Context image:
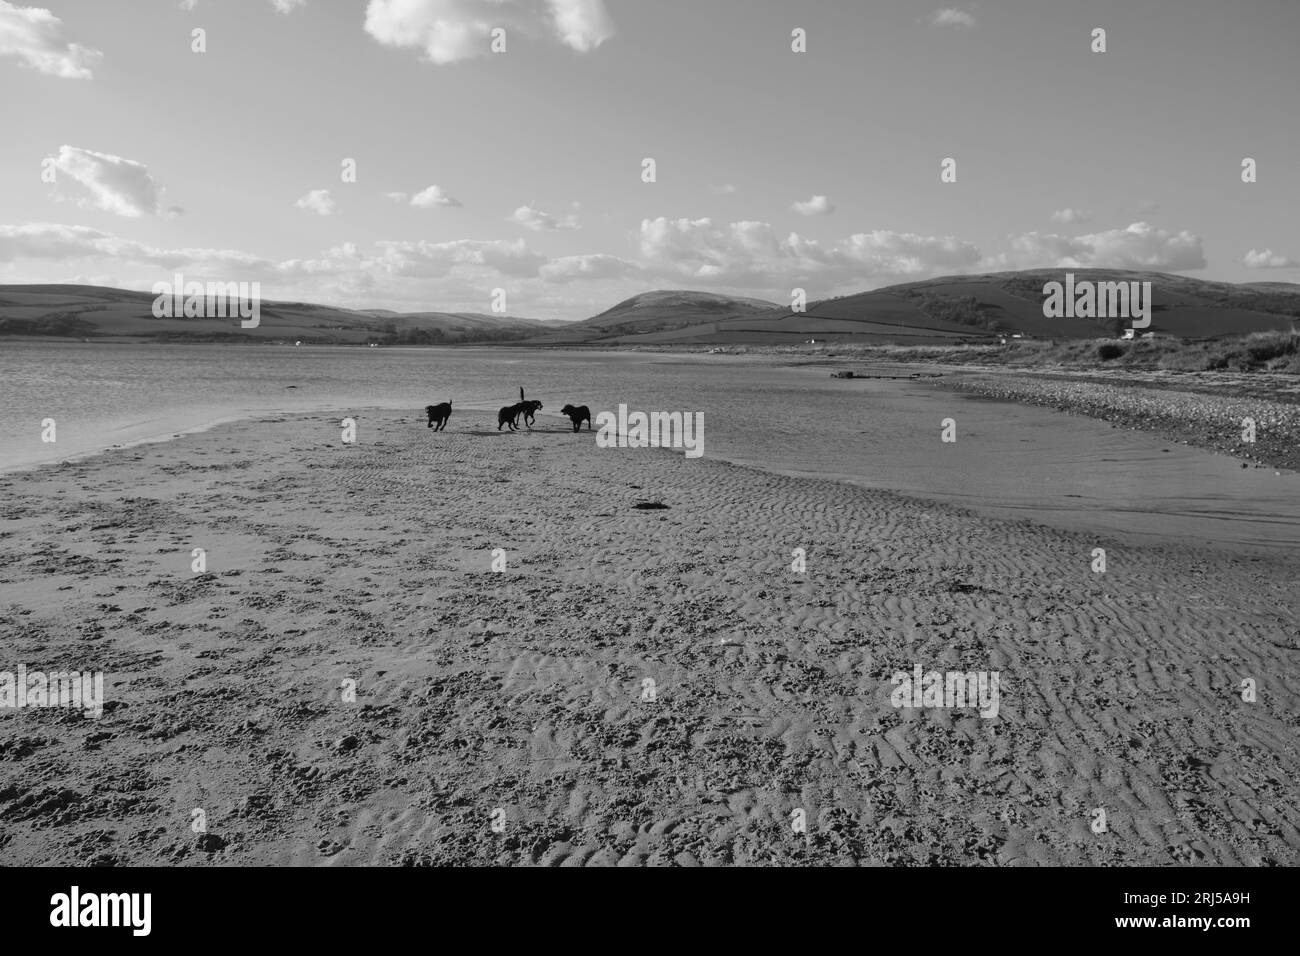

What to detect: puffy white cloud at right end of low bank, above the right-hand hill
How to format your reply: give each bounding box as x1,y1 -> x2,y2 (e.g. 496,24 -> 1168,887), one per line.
1000,222 -> 1205,272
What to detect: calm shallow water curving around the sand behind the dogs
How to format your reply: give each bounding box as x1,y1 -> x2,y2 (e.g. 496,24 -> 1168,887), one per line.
0,343 -> 1300,554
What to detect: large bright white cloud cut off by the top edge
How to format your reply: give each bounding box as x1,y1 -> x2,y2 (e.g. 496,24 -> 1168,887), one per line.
365,0 -> 614,64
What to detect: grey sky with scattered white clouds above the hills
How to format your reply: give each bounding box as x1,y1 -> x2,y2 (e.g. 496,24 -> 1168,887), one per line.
0,0 -> 1300,319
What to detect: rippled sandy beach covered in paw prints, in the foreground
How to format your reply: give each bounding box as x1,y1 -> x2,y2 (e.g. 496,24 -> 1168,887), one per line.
0,411 -> 1300,866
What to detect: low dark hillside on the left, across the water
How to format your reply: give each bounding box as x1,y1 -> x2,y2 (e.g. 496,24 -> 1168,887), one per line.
0,285 -> 559,345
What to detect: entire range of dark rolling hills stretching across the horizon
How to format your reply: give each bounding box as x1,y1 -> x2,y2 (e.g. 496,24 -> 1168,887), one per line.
0,269 -> 1300,346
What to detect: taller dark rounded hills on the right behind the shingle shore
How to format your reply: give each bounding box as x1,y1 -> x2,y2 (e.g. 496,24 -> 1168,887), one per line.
517,269 -> 1300,345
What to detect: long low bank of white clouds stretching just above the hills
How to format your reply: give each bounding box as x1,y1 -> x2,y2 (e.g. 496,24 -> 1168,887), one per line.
0,215 -> 1216,317
